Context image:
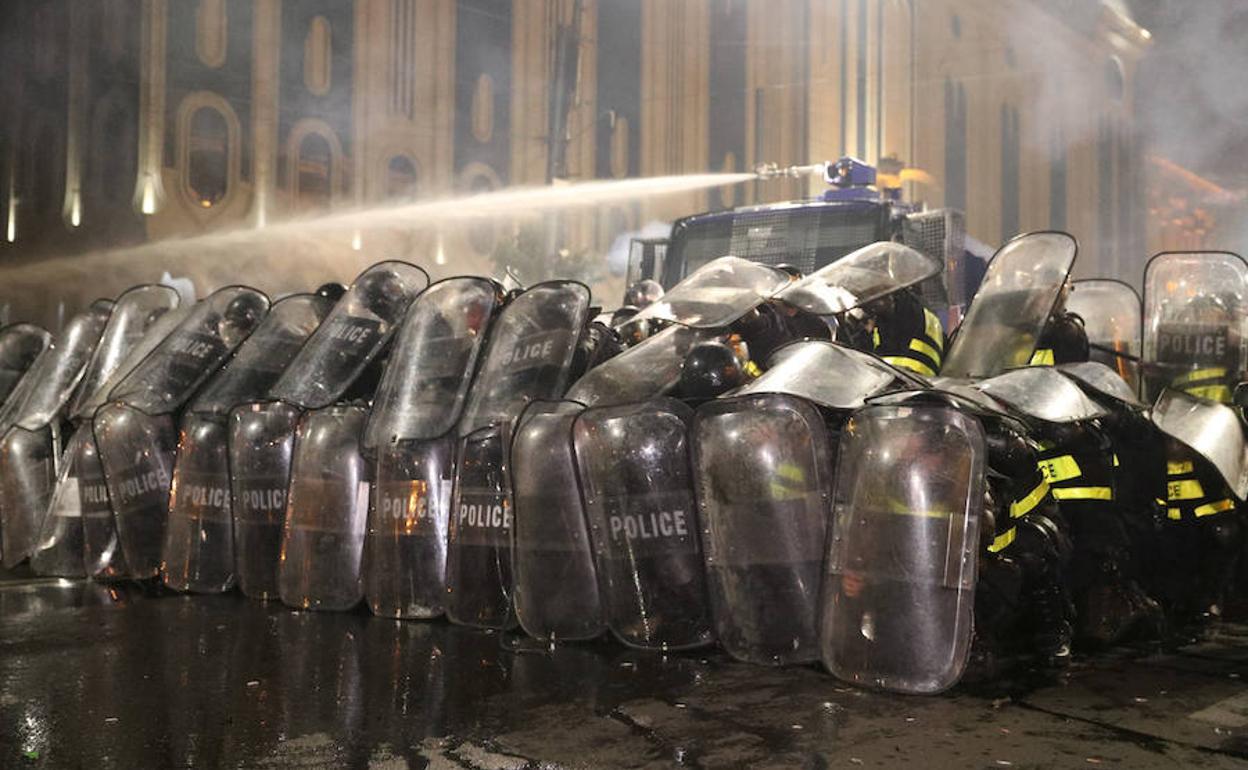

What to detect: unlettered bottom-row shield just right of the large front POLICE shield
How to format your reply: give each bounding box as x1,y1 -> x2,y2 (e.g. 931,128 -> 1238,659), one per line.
693,396 -> 832,665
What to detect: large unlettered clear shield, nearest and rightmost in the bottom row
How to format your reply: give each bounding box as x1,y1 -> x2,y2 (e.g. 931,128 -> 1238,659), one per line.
820,406 -> 987,693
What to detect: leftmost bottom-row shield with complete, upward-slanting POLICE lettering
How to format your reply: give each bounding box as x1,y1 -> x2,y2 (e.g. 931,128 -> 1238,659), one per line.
92,403 -> 177,578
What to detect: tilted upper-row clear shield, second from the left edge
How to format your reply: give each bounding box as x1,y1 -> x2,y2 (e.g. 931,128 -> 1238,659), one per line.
0,303 -> 111,431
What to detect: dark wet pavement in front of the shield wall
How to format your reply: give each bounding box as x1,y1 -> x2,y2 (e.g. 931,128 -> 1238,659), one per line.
0,579 -> 1248,770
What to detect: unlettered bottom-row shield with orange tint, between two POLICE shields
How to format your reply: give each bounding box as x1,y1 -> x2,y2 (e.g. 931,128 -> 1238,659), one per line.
277,406 -> 369,610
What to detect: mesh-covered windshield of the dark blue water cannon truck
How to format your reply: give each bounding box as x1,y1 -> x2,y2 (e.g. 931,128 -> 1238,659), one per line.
663,202 -> 887,287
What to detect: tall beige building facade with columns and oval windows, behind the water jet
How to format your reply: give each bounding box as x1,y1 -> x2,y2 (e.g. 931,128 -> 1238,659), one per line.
0,0 -> 1148,324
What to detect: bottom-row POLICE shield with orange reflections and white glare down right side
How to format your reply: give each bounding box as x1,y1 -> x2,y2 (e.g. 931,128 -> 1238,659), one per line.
364,436 -> 454,618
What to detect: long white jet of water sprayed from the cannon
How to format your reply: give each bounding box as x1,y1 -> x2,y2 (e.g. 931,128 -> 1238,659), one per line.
0,173 -> 756,326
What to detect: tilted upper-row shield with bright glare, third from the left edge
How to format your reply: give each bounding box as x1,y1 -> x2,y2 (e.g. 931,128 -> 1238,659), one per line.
69,283 -> 180,421
